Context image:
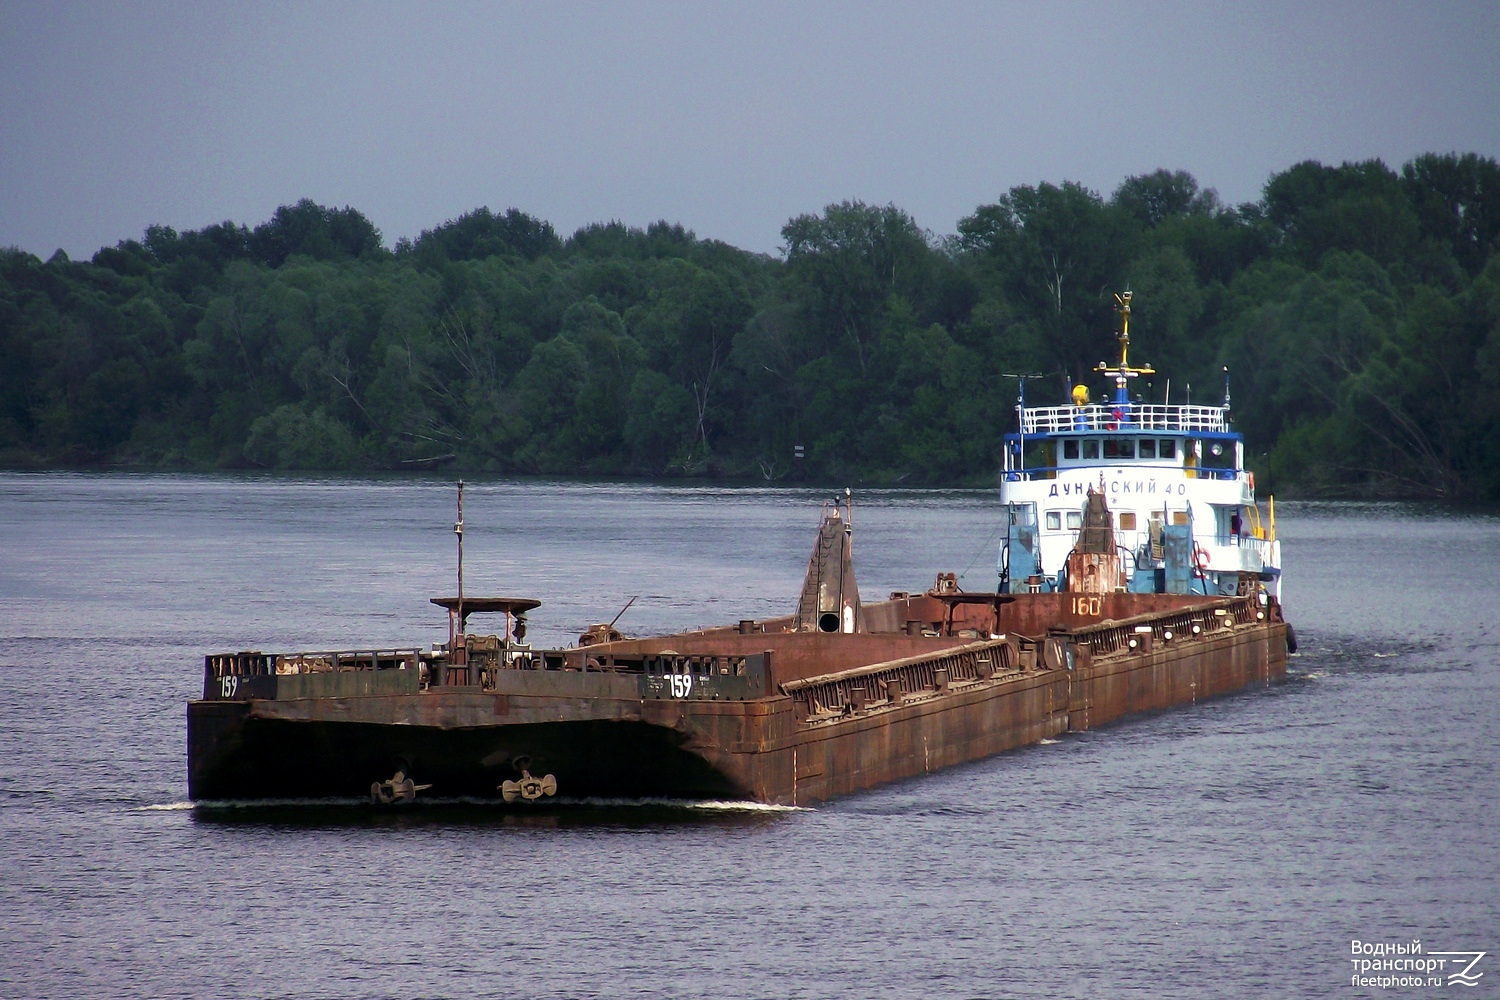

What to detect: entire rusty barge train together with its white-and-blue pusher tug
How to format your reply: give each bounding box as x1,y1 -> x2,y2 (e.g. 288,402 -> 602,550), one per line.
188,294 -> 1295,805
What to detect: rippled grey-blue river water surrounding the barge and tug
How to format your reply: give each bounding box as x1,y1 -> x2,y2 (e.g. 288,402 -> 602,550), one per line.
0,474 -> 1500,997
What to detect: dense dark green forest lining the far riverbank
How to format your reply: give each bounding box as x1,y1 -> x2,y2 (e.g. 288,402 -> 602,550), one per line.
0,154 -> 1500,501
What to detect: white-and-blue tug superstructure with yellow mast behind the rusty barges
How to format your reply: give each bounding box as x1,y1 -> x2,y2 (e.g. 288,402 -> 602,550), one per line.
999,292 -> 1281,598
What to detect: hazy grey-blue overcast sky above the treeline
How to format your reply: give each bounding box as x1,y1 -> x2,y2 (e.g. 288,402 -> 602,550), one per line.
0,0 -> 1500,259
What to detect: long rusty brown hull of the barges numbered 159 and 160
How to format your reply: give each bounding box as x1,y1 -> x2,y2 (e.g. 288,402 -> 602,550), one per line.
188,594 -> 1287,805
